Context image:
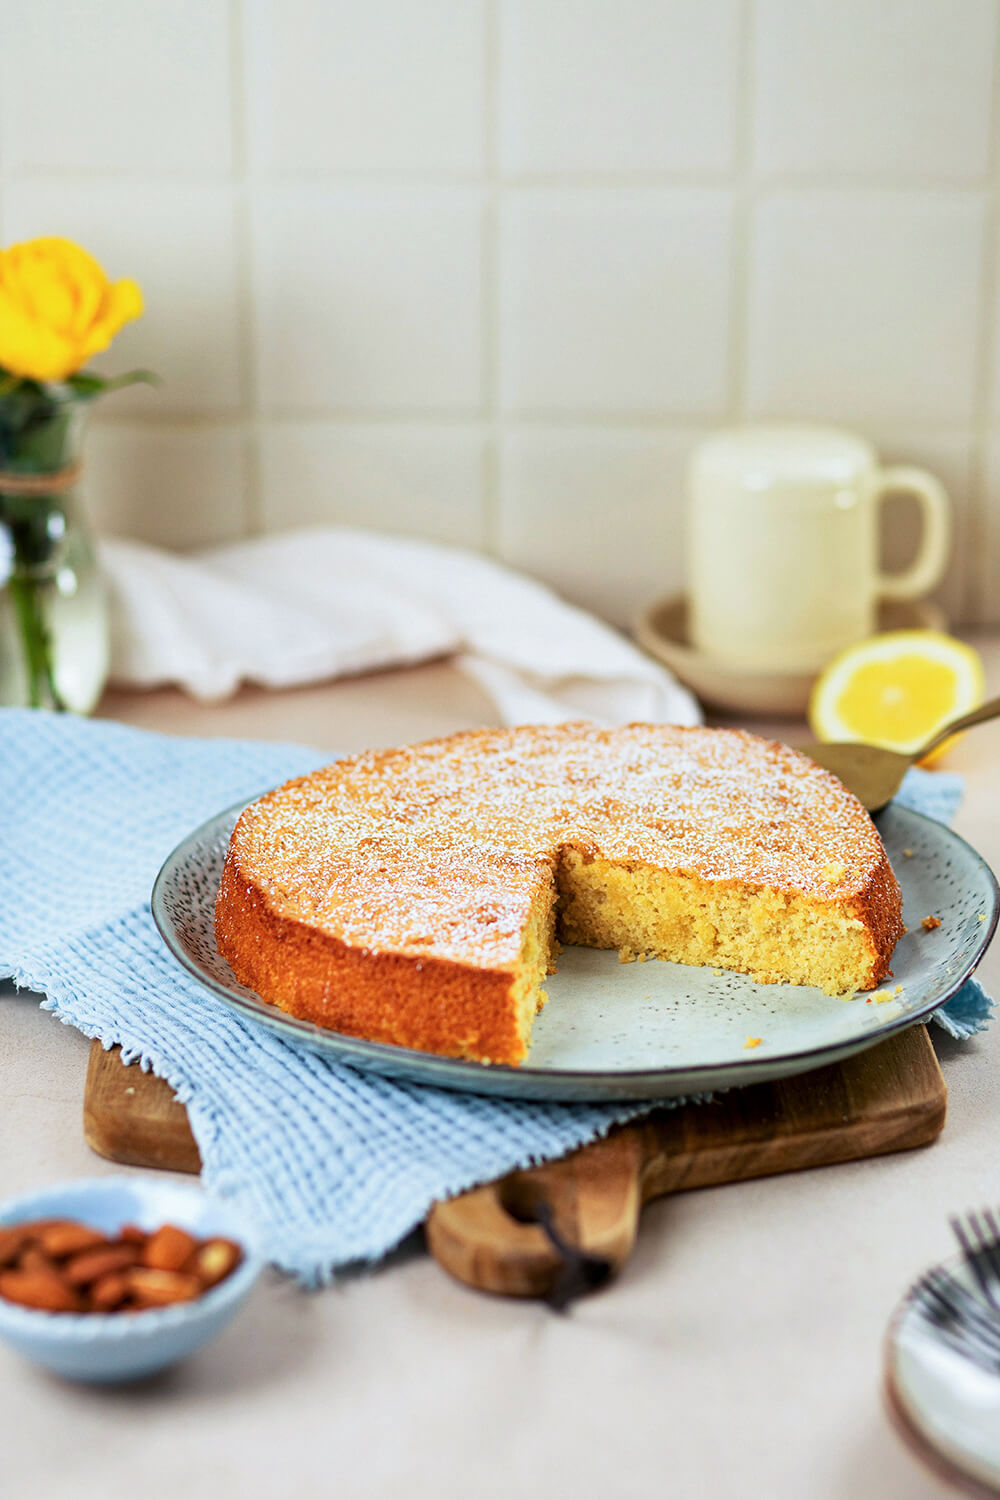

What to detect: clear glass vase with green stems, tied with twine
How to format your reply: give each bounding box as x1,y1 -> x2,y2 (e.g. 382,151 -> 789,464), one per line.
0,399 -> 108,714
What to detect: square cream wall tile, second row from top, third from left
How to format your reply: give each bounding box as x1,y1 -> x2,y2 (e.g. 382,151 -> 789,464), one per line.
499,188 -> 732,416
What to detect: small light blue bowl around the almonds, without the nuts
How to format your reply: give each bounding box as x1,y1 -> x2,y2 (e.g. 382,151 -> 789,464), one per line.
0,1176 -> 261,1382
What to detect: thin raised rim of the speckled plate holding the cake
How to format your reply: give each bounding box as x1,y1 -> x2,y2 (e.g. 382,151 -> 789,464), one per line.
150,792 -> 1000,1101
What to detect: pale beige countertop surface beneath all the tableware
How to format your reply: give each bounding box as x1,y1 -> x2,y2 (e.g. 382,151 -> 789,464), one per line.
0,641 -> 1000,1500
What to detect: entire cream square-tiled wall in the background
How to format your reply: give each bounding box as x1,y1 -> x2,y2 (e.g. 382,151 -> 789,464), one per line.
0,0 -> 1000,623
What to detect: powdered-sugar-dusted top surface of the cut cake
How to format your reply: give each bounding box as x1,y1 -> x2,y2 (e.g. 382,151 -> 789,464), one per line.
232,725 -> 885,968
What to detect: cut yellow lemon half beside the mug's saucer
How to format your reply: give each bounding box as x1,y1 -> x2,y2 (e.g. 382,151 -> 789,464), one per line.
810,630 -> 987,759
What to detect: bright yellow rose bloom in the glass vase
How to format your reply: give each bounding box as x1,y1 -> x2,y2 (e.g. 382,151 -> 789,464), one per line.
0,239 -> 142,381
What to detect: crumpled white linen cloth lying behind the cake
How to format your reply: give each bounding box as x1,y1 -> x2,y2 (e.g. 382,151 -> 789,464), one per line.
100,527 -> 702,725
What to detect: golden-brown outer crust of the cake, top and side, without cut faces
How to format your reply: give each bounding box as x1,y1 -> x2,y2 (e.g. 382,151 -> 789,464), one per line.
216,725 -> 903,1062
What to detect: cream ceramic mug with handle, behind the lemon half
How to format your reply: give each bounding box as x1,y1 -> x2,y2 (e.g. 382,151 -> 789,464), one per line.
688,425 -> 951,672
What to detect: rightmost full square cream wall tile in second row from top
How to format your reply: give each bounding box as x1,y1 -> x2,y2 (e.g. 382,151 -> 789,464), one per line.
748,189 -> 987,425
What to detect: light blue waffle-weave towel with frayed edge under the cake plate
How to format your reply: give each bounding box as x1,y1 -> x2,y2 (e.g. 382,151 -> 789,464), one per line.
0,710 -> 991,1283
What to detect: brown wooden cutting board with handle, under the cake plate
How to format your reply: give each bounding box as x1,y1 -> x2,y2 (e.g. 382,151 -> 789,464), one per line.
84,1026 -> 948,1307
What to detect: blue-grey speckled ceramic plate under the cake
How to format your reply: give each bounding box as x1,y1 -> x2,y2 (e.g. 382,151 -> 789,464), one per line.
153,807 -> 1000,1100
